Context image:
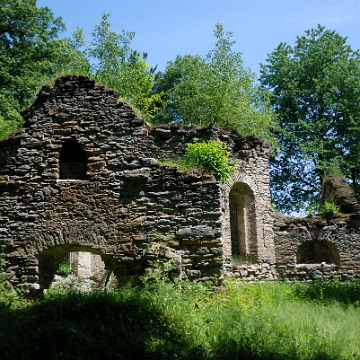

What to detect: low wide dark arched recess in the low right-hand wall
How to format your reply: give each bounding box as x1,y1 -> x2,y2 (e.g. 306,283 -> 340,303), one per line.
296,240 -> 340,266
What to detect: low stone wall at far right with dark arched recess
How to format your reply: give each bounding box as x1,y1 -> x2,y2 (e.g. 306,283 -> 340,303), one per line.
274,213 -> 360,280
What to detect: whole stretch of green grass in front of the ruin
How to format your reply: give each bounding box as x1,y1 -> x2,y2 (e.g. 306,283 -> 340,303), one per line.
0,281 -> 360,360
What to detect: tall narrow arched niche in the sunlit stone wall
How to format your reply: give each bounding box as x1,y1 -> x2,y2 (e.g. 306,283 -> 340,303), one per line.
229,182 -> 258,260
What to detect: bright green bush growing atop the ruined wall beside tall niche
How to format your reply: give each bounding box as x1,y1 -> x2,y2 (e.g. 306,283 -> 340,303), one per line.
186,140 -> 235,182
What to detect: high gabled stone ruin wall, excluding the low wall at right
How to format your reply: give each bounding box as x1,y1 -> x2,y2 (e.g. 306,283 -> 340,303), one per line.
0,77 -> 274,292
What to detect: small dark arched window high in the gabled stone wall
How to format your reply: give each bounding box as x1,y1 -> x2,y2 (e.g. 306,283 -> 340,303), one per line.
60,140 -> 86,180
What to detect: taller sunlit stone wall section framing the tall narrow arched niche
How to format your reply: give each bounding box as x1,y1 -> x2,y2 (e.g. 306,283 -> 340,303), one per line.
154,126 -> 275,264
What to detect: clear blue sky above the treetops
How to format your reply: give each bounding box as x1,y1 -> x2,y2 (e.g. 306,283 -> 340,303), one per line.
37,0 -> 360,73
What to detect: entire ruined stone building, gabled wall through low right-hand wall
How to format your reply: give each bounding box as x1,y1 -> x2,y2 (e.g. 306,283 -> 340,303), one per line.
0,76 -> 360,294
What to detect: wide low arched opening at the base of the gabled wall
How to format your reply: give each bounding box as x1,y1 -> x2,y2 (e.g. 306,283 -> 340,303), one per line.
37,245 -> 116,292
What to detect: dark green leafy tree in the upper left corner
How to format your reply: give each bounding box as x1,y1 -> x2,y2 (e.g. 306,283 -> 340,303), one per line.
0,0 -> 64,138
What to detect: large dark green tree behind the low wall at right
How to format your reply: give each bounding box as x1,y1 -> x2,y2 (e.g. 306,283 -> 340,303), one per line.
260,25 -> 360,212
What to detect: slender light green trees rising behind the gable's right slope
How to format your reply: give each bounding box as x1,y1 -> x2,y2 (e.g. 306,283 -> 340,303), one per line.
67,13 -> 159,118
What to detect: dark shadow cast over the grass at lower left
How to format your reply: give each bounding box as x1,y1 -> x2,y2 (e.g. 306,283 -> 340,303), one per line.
0,283 -> 348,360
